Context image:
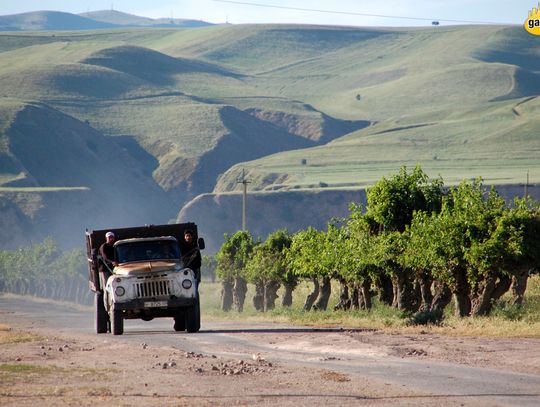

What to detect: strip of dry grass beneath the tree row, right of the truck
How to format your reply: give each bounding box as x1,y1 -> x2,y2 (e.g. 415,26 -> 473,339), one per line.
200,275 -> 540,338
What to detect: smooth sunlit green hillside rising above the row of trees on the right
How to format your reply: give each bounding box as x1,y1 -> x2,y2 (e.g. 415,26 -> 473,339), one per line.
210,27 -> 540,192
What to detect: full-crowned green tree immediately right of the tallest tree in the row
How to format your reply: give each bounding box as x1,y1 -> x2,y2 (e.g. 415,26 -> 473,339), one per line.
405,180 -> 522,316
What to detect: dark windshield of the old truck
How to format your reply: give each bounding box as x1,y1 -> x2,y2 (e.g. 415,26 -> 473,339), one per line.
116,240 -> 180,263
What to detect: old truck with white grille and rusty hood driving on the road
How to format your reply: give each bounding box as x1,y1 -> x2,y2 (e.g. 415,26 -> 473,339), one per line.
86,222 -> 204,335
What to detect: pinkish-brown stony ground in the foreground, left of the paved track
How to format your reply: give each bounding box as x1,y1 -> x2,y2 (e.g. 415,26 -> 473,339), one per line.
0,325 -> 418,406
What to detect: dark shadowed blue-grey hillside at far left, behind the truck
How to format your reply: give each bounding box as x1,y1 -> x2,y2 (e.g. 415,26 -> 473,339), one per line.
0,104 -> 175,247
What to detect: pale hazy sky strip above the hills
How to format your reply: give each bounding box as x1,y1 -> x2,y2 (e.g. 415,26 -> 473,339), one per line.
0,0 -> 538,26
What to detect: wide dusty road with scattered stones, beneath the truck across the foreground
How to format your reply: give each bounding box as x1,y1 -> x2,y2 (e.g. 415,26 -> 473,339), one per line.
0,296 -> 540,406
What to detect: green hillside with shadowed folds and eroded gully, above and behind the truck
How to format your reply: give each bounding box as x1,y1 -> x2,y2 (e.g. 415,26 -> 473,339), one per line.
0,31 -> 367,206
